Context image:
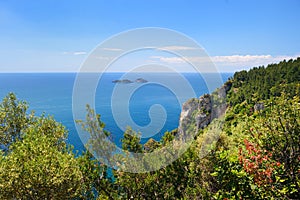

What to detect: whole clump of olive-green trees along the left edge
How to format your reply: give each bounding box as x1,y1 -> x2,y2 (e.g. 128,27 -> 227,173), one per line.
0,93 -> 103,199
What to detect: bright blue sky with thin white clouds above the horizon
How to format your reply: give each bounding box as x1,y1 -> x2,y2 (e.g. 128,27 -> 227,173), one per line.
0,0 -> 300,72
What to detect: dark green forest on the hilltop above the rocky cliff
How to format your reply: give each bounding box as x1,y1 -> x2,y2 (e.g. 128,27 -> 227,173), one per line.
228,57 -> 300,105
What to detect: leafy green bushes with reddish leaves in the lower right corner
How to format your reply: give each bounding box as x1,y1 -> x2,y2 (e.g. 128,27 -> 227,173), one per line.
212,94 -> 300,199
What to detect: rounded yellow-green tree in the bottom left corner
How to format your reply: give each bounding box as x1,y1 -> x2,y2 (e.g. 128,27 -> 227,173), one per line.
0,115 -> 83,199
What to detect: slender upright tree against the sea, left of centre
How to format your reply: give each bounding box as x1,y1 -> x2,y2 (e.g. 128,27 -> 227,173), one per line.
76,105 -> 120,199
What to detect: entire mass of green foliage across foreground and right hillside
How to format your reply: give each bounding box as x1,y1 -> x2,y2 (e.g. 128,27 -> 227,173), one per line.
0,58 -> 300,199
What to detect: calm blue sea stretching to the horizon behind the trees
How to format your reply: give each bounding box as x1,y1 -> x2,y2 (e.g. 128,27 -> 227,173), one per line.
0,73 -> 233,151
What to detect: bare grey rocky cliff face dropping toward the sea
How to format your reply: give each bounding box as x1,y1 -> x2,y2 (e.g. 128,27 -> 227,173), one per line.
178,83 -> 231,135
